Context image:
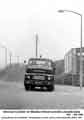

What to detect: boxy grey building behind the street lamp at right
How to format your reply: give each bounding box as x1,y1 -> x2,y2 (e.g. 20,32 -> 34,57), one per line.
64,48 -> 84,74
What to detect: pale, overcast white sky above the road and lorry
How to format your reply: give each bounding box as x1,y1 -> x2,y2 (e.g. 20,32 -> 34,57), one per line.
0,0 -> 84,64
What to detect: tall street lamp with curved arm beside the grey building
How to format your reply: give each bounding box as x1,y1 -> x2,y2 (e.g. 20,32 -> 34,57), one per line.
58,10 -> 83,89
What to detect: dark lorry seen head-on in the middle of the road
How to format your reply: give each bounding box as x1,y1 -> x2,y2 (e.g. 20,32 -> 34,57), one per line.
24,58 -> 55,91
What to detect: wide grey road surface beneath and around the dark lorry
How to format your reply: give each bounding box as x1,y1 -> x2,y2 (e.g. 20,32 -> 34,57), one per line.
0,81 -> 84,109
